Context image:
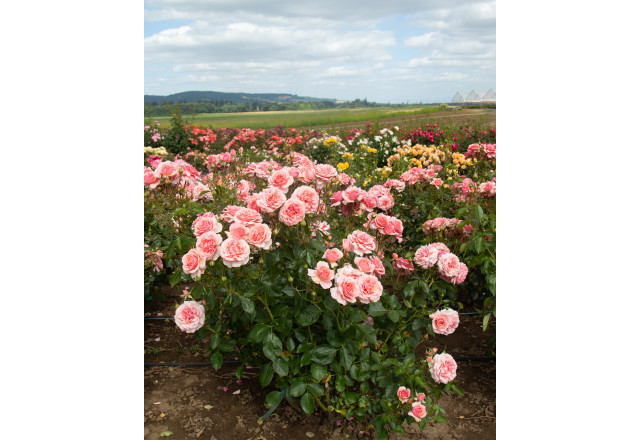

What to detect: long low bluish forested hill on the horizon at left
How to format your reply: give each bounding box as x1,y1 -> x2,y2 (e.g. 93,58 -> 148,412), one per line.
144,91 -> 336,105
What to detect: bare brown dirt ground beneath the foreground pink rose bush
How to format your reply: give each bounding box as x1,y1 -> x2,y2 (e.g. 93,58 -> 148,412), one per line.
144,289 -> 496,440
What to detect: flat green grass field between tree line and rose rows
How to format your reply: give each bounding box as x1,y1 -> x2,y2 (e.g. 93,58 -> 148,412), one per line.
147,106 -> 452,129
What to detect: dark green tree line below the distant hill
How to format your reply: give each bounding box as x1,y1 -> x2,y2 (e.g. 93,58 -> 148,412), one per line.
144,98 -> 385,117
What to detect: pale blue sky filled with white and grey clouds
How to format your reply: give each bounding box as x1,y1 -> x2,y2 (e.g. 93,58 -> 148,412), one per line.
144,0 -> 496,103
